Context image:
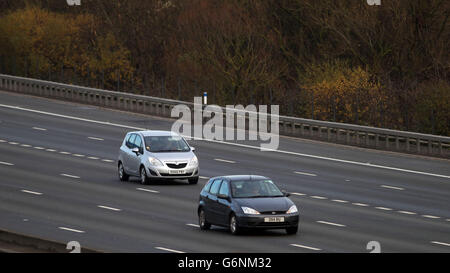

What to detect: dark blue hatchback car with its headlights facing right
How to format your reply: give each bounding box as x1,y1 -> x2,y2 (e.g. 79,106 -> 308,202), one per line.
198,175 -> 299,234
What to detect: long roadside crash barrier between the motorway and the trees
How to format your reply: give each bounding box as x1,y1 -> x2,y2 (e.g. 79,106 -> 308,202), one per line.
0,74 -> 450,158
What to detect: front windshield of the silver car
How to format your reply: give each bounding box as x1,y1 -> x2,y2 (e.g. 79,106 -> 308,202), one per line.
144,136 -> 191,153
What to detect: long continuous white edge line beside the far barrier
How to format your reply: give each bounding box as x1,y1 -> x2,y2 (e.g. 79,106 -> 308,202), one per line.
0,104 -> 450,179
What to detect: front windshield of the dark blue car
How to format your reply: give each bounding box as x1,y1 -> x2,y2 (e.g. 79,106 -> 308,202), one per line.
231,179 -> 283,198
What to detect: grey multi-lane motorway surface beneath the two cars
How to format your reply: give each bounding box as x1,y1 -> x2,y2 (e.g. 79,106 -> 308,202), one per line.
0,91 -> 450,253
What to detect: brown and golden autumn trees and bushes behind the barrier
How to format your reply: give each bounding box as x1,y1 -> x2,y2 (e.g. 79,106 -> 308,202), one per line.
0,0 -> 450,135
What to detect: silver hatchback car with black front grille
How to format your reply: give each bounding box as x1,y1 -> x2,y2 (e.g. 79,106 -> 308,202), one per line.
118,131 -> 199,184
